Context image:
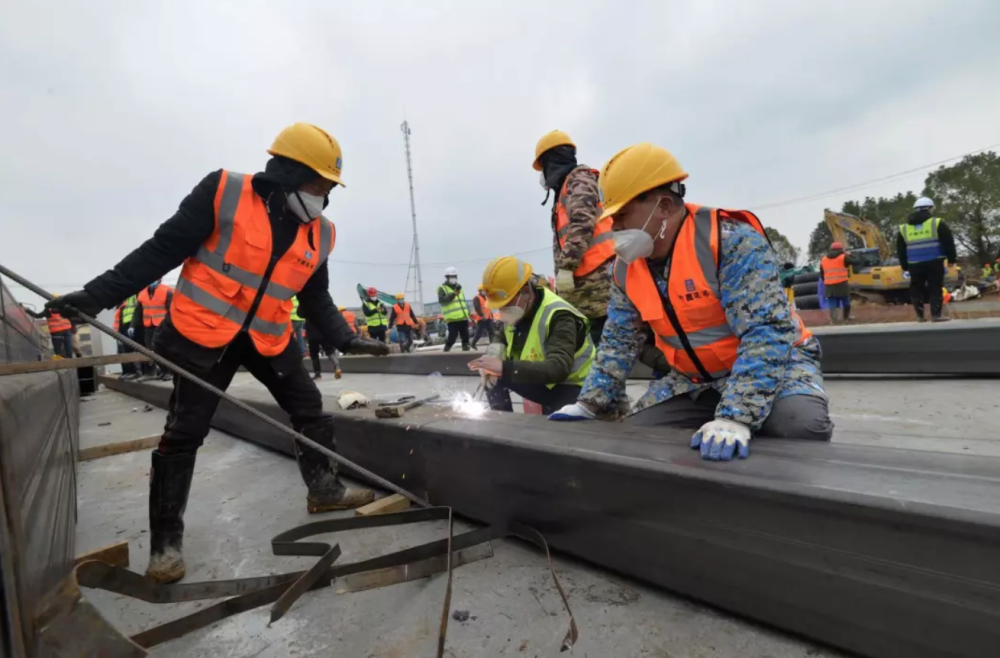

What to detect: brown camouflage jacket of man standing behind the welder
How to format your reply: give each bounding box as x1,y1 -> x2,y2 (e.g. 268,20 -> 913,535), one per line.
552,165 -> 611,318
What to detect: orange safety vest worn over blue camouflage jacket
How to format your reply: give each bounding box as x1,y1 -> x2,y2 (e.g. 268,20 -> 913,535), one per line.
613,203 -> 812,382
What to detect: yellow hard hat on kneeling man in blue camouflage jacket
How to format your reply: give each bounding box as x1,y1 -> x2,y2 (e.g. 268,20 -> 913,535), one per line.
597,142 -> 687,219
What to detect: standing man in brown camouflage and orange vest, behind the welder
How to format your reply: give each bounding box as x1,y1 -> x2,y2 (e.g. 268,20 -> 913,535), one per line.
534,130 -> 615,345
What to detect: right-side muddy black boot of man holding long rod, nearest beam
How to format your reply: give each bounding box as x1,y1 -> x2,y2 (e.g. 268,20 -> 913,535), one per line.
295,416 -> 375,514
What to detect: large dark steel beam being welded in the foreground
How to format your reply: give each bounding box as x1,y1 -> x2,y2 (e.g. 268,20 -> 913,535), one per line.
104,378 -> 1000,658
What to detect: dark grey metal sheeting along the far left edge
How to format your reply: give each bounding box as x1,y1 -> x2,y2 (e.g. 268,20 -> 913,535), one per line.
0,276 -> 80,658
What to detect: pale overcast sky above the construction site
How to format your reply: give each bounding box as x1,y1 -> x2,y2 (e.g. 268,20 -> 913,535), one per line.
0,0 -> 1000,305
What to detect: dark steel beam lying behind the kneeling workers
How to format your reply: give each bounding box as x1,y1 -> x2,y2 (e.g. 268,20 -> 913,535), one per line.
318,319 -> 1000,379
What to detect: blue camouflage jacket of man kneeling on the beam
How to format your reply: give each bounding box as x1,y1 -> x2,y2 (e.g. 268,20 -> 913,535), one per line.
579,219 -> 826,430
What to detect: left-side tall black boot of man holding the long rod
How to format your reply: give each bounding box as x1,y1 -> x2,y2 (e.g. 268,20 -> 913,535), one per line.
146,450 -> 195,584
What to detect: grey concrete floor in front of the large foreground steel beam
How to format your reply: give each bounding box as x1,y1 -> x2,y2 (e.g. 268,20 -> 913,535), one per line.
77,390 -> 844,658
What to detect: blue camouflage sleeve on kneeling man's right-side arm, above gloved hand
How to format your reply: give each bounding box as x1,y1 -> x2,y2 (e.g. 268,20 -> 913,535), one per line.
715,220 -> 798,430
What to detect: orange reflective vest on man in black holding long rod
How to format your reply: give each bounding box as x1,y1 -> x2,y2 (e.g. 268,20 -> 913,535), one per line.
170,170 -> 337,356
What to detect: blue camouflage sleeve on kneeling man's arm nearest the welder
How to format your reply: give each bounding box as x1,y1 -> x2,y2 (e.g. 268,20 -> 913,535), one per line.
579,285 -> 646,413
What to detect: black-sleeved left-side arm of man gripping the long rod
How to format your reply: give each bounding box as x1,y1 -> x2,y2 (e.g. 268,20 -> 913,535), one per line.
84,170 -> 222,308
